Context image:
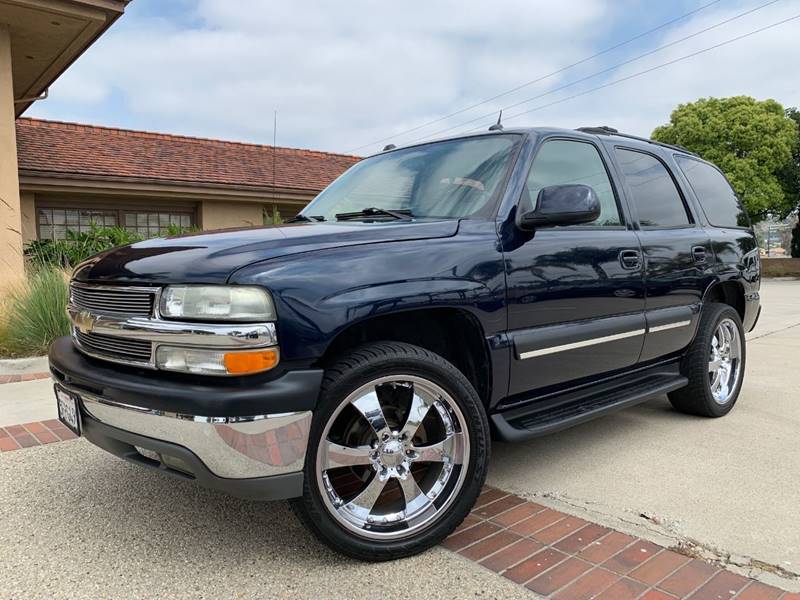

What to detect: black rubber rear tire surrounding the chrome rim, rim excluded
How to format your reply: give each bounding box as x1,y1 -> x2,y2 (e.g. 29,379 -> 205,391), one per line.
668,303 -> 747,417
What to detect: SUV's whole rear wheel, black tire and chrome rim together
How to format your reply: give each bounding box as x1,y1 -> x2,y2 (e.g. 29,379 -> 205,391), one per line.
668,303 -> 747,417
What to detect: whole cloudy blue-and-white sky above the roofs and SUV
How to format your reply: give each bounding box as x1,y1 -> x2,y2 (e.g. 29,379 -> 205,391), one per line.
26,0 -> 800,154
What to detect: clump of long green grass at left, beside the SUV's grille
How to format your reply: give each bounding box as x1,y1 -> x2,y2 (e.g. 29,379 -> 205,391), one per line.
0,268 -> 69,357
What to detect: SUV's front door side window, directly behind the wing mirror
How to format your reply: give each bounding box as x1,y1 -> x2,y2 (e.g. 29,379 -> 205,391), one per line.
522,140 -> 622,226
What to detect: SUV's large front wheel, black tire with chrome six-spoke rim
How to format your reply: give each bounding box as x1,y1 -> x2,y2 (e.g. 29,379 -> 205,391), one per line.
293,342 -> 490,561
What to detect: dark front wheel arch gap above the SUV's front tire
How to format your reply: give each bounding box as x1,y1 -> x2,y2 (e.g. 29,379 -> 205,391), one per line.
318,307 -> 492,406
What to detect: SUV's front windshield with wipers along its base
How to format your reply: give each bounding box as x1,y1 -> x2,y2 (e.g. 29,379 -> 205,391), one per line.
301,135 -> 519,221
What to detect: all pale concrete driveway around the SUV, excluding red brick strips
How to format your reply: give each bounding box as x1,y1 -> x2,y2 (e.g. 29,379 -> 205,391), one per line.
0,281 -> 800,598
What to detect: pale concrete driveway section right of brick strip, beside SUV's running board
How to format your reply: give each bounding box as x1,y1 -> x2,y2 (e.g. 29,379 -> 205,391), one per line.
488,280 -> 800,574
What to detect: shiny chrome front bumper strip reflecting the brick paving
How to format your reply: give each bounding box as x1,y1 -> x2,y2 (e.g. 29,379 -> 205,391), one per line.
67,387 -> 312,479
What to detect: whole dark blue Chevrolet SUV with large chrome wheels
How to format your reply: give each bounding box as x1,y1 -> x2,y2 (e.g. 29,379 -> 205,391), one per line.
50,127 -> 760,560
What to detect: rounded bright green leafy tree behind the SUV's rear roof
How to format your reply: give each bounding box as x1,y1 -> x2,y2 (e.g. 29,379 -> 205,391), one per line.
652,96 -> 798,221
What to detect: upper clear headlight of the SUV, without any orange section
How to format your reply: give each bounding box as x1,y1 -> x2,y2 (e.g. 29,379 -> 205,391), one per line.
160,285 -> 275,322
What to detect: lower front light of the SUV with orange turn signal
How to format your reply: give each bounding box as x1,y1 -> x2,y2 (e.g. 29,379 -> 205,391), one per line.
156,346 -> 278,375
